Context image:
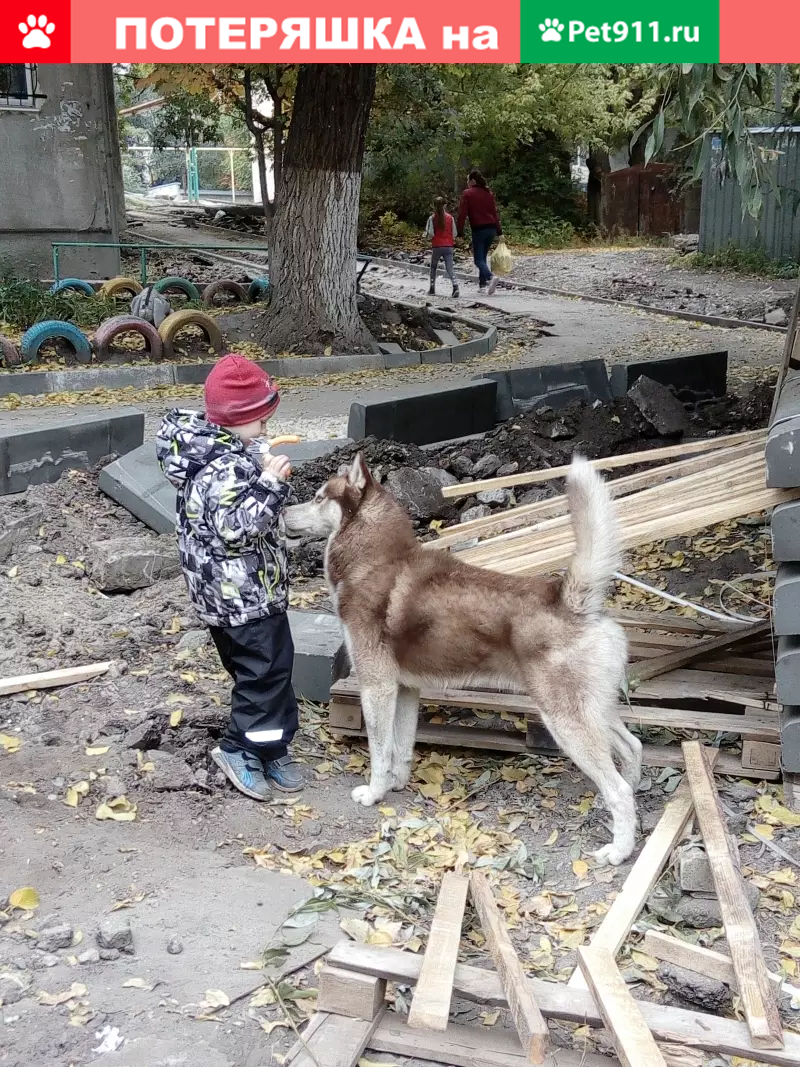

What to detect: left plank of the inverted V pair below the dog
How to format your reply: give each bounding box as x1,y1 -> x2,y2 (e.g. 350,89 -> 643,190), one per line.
409,873 -> 469,1032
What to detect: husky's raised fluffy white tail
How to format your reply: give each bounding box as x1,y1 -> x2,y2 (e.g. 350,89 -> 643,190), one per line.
561,457 -> 622,616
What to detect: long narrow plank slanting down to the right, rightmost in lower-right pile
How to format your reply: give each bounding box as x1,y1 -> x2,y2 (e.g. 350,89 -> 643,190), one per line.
683,740 -> 783,1049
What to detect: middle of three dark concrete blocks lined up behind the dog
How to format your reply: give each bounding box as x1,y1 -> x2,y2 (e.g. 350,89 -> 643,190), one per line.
481,360 -> 611,421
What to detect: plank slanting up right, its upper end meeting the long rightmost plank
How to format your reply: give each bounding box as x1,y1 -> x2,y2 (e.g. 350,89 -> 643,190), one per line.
569,749 -> 719,989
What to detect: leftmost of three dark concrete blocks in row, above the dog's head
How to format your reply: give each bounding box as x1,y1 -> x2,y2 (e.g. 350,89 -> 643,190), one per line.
348,380 -> 497,445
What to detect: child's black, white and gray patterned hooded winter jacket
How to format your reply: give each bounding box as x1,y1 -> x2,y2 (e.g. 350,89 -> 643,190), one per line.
156,409 -> 292,626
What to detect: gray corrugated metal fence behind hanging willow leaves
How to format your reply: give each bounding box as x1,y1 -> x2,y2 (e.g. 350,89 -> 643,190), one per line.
700,126 -> 800,260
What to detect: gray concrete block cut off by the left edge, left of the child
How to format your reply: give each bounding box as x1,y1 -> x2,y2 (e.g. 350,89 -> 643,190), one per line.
0,408 -> 144,496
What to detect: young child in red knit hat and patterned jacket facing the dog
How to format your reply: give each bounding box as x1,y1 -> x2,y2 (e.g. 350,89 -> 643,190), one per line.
156,355 -> 303,800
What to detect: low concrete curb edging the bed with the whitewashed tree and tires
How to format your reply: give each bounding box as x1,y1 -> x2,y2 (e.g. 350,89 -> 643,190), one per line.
0,309 -> 498,397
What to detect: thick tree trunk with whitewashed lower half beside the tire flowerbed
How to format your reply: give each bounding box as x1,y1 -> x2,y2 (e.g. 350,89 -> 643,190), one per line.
258,63 -> 377,354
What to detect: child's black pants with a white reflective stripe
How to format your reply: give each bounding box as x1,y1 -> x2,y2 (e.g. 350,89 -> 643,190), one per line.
209,611 -> 298,760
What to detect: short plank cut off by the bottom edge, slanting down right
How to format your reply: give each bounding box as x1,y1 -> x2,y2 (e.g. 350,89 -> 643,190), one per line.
578,945 -> 667,1067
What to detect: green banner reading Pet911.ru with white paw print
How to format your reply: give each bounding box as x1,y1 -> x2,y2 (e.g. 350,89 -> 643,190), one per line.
521,0 -> 719,63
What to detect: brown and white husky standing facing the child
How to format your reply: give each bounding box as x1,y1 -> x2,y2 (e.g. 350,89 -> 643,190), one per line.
284,453 -> 641,864
